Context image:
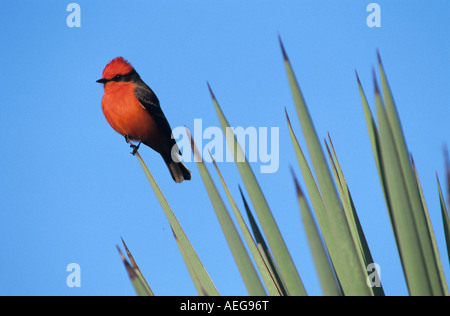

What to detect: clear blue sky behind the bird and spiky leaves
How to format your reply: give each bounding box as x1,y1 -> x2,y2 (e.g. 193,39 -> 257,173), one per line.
0,0 -> 450,295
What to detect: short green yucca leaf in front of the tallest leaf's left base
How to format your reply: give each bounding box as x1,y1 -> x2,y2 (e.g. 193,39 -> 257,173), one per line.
291,170 -> 341,296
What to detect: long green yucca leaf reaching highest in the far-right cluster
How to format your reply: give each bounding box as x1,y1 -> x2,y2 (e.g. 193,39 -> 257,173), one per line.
378,54 -> 444,295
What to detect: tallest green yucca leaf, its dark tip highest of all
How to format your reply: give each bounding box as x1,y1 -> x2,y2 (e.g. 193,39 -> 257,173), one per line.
280,38 -> 373,295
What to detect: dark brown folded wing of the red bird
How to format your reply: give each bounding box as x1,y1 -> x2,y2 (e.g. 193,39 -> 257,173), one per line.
134,80 -> 181,154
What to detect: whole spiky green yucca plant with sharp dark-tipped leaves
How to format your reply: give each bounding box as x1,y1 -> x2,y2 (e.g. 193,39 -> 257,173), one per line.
119,39 -> 450,296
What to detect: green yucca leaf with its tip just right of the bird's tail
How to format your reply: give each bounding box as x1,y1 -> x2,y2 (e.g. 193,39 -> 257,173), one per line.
186,128 -> 266,296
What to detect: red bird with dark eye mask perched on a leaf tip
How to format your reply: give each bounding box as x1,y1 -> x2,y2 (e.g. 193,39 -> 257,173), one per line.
97,57 -> 191,183
